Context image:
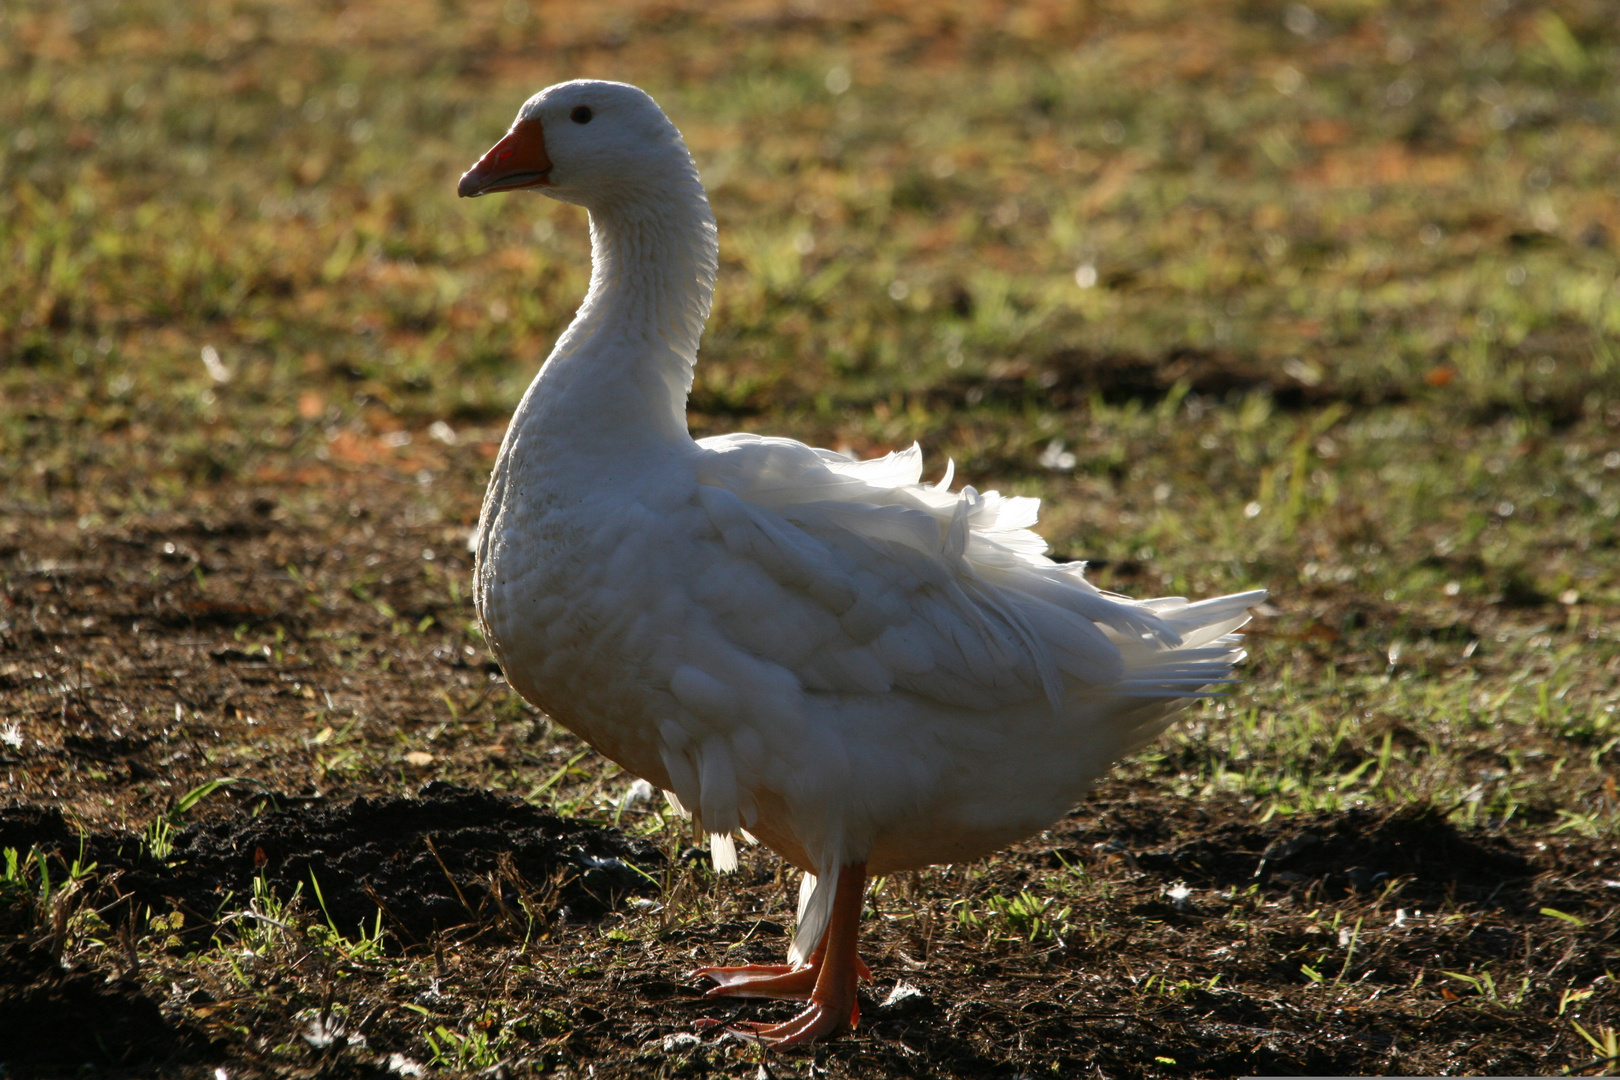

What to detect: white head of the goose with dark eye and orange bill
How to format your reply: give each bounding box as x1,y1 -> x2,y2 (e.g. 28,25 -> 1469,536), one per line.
455,79 -> 697,210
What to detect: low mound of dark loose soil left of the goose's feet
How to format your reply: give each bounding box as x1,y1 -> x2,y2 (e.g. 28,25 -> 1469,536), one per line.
0,782 -> 664,946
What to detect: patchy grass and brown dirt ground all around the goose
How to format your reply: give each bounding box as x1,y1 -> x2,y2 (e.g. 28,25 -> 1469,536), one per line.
0,0 -> 1620,1078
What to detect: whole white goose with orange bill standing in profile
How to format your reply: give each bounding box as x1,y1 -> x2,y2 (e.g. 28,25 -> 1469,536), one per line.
457,81 -> 1265,1043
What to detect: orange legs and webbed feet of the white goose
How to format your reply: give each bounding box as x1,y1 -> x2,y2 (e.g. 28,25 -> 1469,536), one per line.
698,863 -> 872,1046
